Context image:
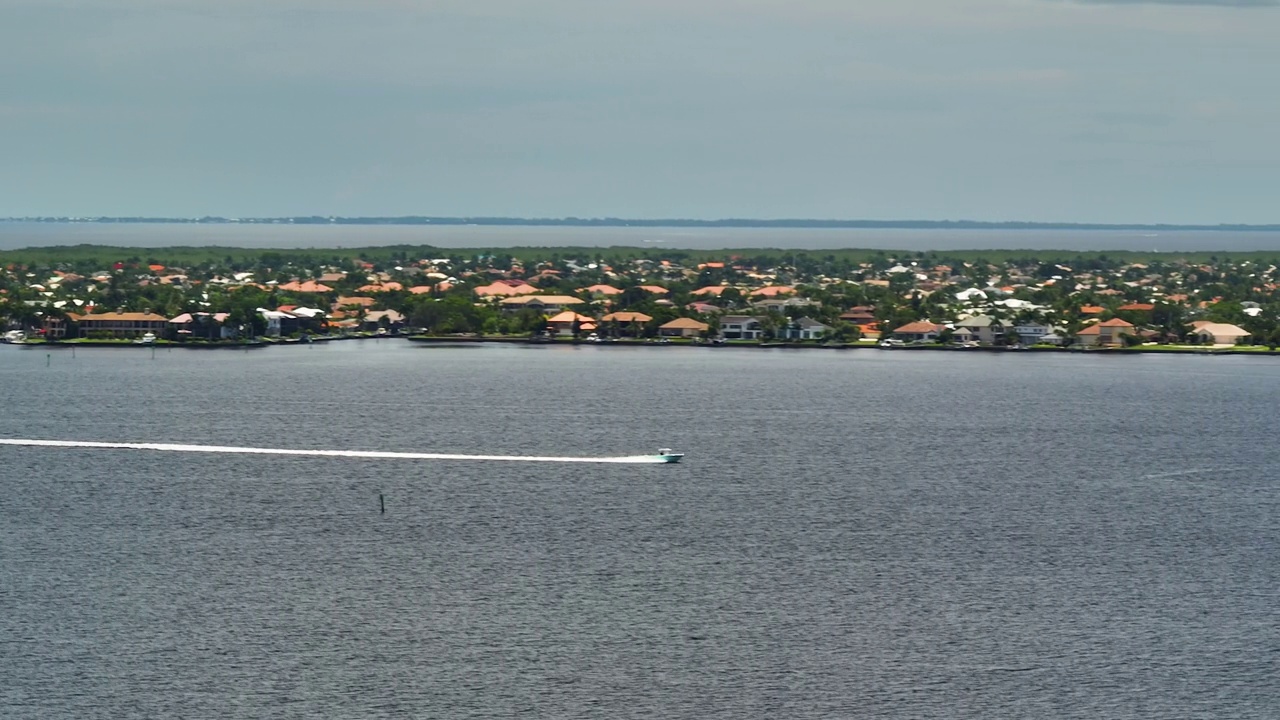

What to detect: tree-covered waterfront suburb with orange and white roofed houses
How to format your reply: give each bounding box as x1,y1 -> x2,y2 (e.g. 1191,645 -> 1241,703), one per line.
0,245 -> 1280,355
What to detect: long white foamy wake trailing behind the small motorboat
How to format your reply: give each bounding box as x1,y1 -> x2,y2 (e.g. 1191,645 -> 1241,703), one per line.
0,438 -> 662,464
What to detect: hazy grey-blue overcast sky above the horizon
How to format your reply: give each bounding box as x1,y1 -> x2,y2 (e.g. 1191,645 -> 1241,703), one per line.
0,0 -> 1280,224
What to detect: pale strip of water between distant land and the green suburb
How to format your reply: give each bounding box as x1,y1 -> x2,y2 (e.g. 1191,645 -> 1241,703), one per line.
0,223 -> 1280,251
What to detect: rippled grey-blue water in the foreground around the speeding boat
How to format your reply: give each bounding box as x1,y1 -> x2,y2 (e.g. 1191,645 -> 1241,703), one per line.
0,341 -> 1280,719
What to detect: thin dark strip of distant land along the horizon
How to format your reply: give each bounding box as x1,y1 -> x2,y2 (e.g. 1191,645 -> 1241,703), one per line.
0,215 -> 1280,232
